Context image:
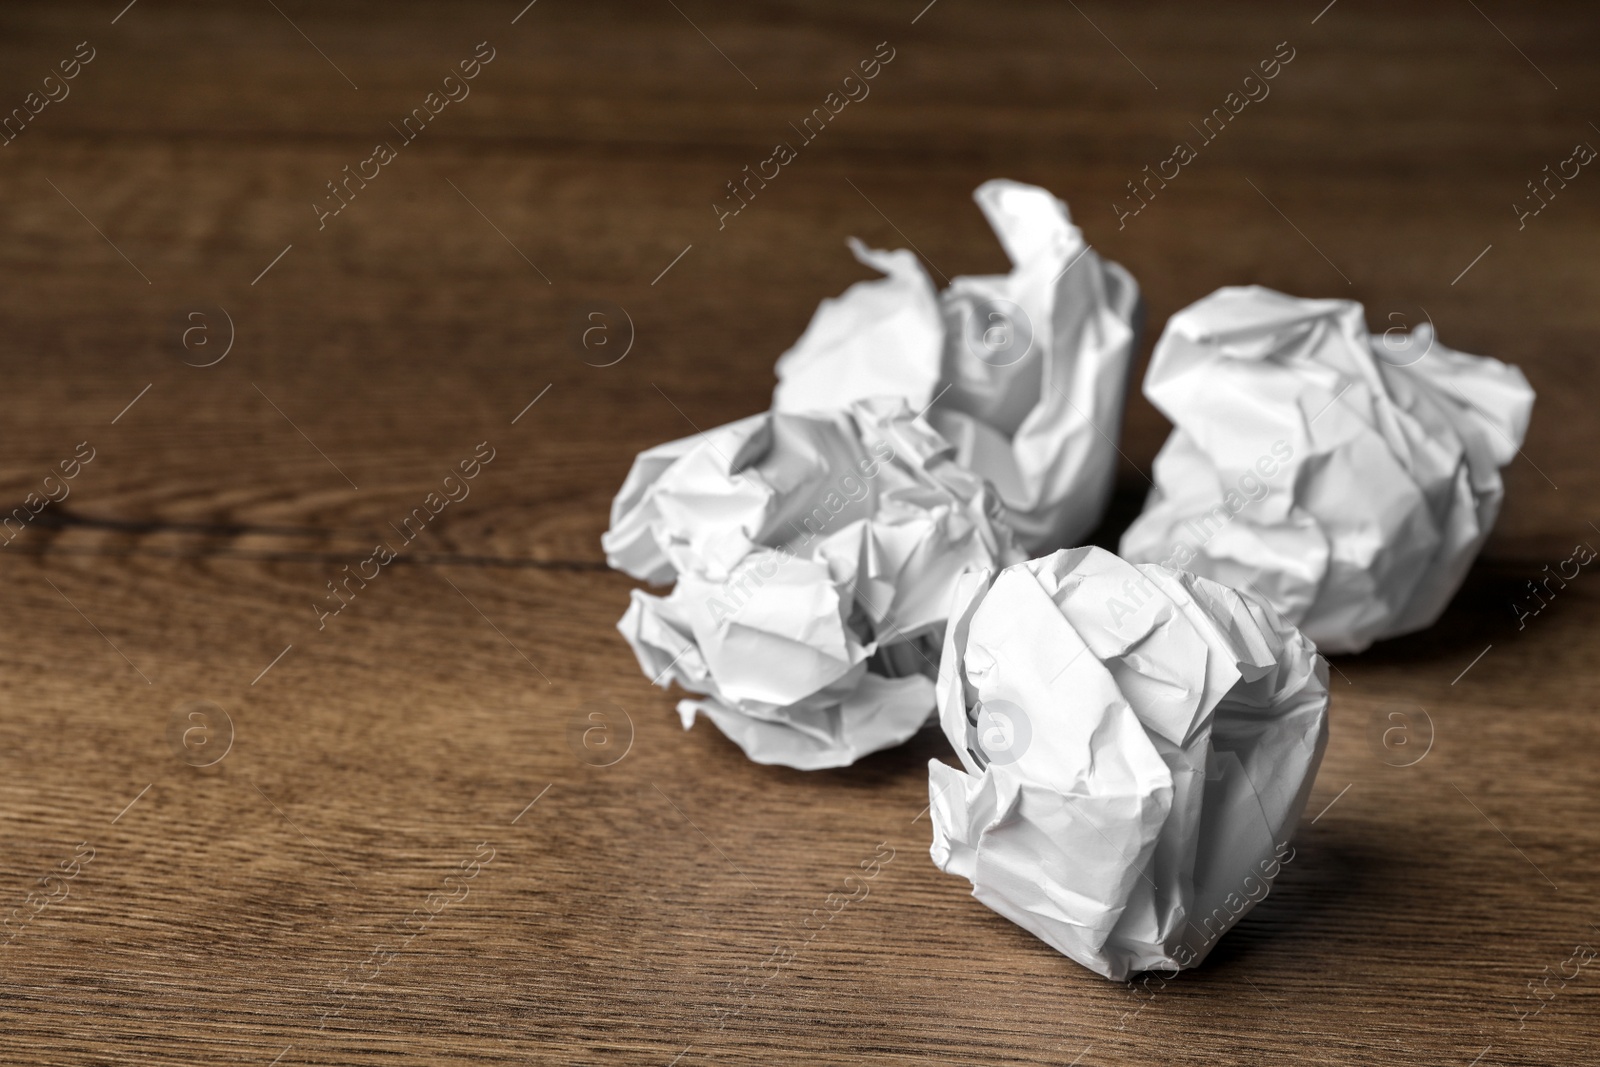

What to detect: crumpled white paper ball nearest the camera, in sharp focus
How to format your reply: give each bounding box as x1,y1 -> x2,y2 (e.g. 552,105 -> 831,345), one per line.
928,549 -> 1328,981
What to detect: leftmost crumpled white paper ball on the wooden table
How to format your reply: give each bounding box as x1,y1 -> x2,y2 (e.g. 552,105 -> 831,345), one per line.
602,398 -> 1021,769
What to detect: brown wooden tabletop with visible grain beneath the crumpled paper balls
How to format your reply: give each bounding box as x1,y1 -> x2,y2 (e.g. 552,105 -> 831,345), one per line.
0,0 -> 1600,1067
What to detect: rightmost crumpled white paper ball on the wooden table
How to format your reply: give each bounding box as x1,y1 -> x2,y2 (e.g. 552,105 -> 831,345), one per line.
1120,286 -> 1533,653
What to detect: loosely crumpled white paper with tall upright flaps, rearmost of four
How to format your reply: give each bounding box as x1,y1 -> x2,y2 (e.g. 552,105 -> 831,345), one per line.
773,181 -> 1142,553
